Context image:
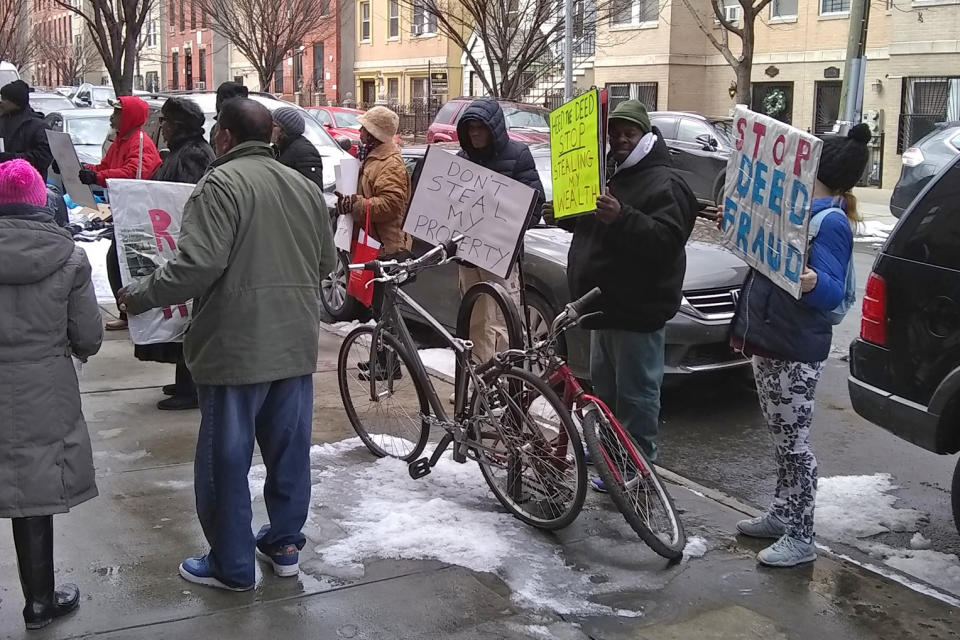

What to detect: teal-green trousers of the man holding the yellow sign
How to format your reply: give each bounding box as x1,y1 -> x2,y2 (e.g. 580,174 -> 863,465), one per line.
590,329 -> 664,462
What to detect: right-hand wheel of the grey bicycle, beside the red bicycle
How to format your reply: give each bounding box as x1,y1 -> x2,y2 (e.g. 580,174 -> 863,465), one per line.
469,367 -> 587,529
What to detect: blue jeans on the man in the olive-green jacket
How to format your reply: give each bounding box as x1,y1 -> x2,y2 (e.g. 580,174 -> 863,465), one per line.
194,376 -> 313,586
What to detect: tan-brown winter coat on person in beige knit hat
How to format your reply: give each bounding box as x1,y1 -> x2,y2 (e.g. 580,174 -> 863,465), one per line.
353,142 -> 412,256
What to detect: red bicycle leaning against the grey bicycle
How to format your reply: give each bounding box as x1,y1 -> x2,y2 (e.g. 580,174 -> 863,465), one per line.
495,289 -> 686,560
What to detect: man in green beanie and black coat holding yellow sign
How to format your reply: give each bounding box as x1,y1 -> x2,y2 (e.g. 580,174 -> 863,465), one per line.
544,100 -> 697,478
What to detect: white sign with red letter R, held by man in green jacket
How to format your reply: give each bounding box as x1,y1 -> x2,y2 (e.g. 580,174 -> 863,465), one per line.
107,179 -> 194,344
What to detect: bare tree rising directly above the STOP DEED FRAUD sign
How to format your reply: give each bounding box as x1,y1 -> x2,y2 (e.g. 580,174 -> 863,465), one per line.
681,0 -> 773,105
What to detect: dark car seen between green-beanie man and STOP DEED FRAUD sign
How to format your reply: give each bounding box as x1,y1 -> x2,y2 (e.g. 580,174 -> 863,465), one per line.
650,111 -> 733,205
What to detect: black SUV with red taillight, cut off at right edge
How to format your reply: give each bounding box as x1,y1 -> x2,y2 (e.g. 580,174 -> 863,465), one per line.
848,156 -> 960,530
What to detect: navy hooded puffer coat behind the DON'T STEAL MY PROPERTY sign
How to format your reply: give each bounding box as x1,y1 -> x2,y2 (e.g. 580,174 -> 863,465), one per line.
457,100 -> 544,228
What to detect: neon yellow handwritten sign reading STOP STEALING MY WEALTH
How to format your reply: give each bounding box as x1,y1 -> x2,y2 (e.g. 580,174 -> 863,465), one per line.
550,89 -> 604,218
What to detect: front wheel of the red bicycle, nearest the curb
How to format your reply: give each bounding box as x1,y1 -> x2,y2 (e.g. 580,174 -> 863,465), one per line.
583,404 -> 687,560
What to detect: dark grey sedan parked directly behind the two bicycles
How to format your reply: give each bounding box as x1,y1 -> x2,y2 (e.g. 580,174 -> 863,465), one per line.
322,144 -> 749,379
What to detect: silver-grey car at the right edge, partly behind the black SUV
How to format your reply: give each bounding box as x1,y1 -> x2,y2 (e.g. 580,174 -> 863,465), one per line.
890,121 -> 960,218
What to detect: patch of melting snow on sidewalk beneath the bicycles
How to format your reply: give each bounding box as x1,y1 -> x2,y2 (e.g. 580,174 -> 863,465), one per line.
274,438 -> 641,617
